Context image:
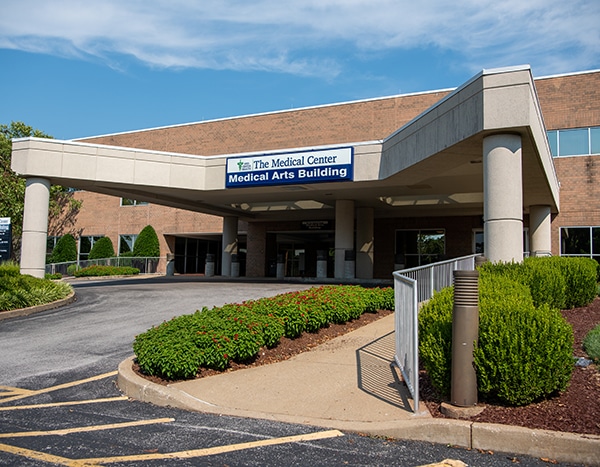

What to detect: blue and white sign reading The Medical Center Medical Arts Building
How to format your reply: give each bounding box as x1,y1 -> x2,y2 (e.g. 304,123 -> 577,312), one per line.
225,148 -> 354,188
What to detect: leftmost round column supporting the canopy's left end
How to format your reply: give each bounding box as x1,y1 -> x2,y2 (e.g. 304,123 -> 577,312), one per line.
21,178 -> 50,277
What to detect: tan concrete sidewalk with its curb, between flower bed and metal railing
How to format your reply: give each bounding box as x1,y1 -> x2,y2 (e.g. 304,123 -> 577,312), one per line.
118,314 -> 600,465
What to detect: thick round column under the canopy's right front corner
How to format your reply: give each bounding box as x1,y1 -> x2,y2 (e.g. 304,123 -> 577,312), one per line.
483,134 -> 523,262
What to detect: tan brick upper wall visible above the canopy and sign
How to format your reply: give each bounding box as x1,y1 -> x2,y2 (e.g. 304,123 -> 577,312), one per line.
78,92 -> 447,156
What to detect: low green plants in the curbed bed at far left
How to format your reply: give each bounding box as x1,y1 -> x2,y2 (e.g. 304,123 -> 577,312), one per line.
0,262 -> 73,311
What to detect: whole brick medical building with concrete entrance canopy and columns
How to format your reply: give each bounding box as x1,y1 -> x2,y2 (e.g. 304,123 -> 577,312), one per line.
12,66 -> 600,279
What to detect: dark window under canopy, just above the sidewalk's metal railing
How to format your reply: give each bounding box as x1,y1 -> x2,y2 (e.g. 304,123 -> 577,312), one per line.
396,229 -> 446,268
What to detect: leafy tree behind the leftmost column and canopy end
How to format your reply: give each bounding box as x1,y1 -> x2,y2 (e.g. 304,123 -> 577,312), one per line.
0,122 -> 81,259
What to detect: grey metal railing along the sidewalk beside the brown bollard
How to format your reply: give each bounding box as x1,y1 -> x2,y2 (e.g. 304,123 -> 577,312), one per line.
394,255 -> 479,412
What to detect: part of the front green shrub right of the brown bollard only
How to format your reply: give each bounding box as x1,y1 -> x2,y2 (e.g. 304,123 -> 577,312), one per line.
474,274 -> 574,405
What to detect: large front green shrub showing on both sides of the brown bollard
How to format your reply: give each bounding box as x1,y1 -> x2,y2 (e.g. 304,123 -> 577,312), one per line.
419,265 -> 573,405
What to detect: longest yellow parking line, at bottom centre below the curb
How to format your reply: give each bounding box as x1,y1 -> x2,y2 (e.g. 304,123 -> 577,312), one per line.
80,430 -> 344,465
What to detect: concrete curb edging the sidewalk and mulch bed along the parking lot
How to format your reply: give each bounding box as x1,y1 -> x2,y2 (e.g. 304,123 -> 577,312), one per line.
117,357 -> 600,466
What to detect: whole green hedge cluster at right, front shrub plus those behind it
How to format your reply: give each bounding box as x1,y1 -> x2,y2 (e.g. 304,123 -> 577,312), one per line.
419,257 -> 597,405
